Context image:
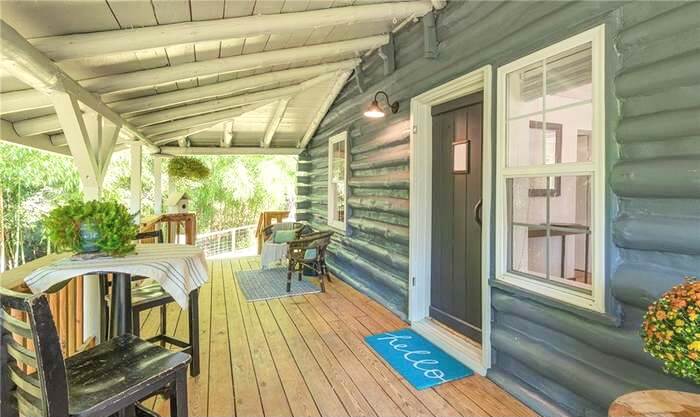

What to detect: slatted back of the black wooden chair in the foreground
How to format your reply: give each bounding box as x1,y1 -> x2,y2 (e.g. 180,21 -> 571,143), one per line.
0,288 -> 68,417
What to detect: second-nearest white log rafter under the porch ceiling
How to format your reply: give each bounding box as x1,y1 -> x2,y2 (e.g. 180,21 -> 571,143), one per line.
81,35 -> 389,94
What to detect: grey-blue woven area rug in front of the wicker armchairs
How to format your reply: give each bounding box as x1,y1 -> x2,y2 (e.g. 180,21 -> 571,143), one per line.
235,268 -> 321,301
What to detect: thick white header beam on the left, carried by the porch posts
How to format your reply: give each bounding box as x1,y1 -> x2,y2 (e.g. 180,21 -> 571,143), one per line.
0,20 -> 156,150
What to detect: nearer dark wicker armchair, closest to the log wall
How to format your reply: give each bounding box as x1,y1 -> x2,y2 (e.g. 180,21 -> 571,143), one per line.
287,232 -> 333,292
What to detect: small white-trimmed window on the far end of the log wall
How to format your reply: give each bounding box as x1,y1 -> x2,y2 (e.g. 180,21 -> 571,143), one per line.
328,132 -> 348,233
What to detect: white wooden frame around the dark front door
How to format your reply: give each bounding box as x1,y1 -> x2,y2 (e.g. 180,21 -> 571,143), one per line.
408,65 -> 493,375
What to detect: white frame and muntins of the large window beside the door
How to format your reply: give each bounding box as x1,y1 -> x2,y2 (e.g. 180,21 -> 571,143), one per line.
495,25 -> 606,313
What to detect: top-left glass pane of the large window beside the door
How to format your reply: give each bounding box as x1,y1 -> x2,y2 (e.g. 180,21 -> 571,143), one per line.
506,62 -> 544,119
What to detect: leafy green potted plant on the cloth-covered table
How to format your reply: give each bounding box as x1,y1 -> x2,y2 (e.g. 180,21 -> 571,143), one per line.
44,200 -> 138,255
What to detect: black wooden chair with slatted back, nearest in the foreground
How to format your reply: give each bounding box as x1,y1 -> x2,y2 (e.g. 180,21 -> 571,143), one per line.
0,288 -> 190,417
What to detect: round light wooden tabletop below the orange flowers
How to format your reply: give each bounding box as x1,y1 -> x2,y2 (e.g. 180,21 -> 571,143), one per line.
608,390 -> 700,417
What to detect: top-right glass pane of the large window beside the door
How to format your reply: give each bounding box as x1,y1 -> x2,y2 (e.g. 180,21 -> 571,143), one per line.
546,43 -> 593,105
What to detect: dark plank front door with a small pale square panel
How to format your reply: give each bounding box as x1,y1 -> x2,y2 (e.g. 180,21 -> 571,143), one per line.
430,93 -> 483,342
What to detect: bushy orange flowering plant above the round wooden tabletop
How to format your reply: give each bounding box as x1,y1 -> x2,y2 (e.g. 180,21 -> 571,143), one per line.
641,277 -> 700,384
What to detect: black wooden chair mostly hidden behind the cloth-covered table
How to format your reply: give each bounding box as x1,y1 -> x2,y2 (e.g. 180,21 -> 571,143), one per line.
100,230 -> 199,376
